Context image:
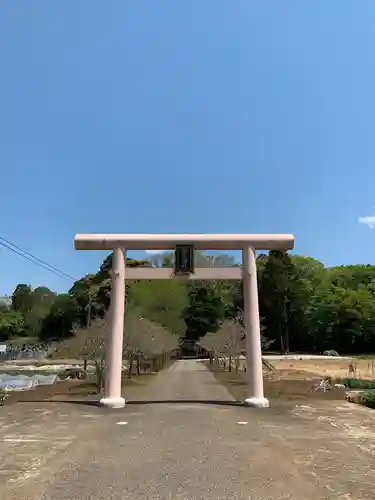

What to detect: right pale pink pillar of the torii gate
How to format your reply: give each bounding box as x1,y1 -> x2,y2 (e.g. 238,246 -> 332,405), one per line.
242,246 -> 269,408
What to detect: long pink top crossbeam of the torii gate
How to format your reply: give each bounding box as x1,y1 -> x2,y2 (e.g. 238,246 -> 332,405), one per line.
74,234 -> 294,250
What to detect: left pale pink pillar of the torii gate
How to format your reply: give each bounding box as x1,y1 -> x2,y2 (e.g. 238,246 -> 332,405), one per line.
100,248 -> 125,408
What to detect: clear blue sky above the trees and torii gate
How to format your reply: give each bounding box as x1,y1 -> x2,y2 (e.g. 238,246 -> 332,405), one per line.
0,0 -> 375,295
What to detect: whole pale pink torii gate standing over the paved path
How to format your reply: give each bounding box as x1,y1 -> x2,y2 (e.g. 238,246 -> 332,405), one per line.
74,234 -> 294,408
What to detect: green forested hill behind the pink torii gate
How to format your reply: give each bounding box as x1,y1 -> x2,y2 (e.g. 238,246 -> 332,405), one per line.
0,251 -> 375,354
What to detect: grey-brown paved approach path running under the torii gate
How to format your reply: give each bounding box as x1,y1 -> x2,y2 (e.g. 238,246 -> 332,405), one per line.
0,361 -> 375,500
